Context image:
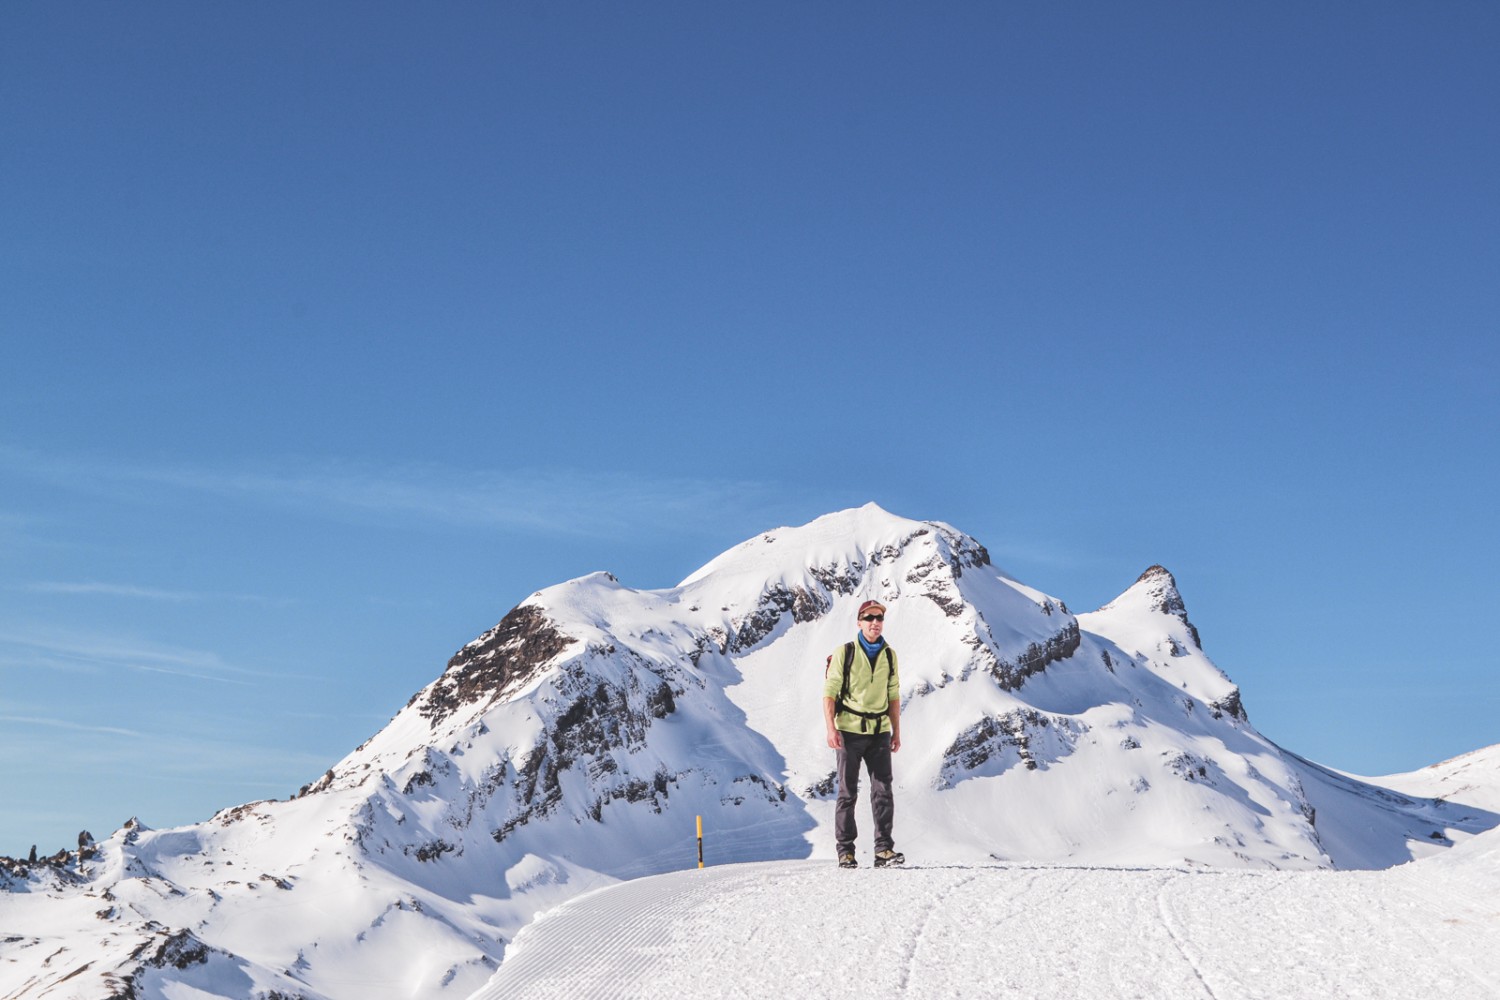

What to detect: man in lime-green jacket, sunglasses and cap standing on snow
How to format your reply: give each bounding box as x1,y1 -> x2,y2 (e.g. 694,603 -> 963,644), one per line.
824,601 -> 906,868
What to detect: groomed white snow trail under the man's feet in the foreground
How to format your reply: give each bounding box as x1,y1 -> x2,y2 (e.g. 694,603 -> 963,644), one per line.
471,861 -> 1500,1000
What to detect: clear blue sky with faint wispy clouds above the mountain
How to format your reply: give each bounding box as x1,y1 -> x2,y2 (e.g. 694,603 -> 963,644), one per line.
0,1 -> 1500,853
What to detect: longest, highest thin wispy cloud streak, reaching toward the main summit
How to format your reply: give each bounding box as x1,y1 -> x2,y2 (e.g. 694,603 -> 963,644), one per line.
0,448 -> 777,537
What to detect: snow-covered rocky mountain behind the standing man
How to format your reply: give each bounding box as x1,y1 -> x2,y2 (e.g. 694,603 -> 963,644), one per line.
0,505 -> 1500,1000
